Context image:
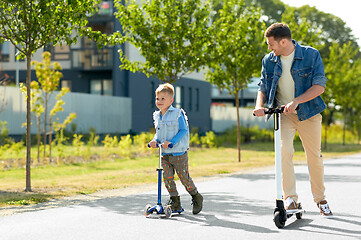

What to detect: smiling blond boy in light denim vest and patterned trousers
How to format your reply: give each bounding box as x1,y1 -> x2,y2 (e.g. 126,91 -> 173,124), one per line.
149,83 -> 203,214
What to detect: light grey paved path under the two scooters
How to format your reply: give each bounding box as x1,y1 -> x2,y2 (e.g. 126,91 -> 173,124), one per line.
0,155 -> 361,240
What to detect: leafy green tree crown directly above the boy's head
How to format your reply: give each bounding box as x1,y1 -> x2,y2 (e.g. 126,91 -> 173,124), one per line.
115,0 -> 210,83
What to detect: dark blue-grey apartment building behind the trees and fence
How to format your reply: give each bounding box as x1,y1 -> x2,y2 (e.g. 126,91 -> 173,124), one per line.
0,1 -> 211,133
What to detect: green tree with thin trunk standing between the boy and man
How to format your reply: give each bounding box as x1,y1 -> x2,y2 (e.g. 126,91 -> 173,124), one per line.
206,0 -> 267,161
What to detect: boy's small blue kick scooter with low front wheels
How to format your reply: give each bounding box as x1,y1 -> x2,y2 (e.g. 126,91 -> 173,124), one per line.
144,144 -> 184,218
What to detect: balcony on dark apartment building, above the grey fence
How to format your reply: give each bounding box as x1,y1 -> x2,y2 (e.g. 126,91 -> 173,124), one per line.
71,48 -> 113,70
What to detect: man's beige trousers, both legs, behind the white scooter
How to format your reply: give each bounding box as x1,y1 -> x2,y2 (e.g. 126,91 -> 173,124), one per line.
281,113 -> 325,203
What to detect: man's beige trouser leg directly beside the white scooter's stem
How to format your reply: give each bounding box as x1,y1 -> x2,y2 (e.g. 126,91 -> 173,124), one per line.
281,114 -> 298,203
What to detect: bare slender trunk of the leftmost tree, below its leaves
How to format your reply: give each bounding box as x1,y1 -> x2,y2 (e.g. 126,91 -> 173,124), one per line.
25,53 -> 32,192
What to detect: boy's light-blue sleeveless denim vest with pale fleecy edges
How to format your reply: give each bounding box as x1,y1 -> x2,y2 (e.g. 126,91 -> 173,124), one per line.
153,106 -> 189,153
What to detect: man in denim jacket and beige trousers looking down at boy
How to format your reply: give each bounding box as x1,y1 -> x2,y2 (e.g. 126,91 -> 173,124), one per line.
253,23 -> 333,217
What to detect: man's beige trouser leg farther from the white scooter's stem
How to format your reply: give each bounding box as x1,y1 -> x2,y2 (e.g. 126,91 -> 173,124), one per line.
298,114 -> 325,203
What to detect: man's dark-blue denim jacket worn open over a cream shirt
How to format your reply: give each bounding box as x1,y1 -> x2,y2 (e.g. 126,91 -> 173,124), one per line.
258,40 -> 327,121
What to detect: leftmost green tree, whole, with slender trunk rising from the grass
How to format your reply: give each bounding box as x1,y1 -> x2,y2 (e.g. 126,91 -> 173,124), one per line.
0,0 -> 100,192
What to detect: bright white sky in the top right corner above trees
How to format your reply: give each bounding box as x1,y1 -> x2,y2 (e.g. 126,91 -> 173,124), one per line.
281,0 -> 361,46
